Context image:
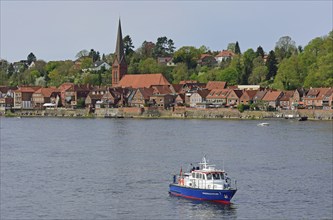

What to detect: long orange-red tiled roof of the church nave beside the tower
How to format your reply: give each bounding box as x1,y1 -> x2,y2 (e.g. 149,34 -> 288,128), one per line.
118,73 -> 170,88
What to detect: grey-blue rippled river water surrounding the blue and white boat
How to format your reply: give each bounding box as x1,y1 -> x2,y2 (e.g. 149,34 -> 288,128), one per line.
0,117 -> 333,219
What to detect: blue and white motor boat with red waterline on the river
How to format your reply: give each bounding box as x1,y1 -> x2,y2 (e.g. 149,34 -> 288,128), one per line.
169,157 -> 237,204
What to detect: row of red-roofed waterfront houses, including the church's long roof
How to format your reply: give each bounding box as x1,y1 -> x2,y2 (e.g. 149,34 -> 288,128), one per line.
0,74 -> 333,111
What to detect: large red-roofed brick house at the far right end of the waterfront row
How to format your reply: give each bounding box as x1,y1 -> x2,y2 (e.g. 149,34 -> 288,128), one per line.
304,88 -> 331,109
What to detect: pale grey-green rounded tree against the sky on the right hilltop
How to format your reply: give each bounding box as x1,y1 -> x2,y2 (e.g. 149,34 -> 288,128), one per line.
275,36 -> 297,62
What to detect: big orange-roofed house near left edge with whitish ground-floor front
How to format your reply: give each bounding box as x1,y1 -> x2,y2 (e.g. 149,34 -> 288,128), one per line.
13,86 -> 41,109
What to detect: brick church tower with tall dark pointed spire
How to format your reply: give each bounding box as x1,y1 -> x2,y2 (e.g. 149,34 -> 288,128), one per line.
112,19 -> 127,87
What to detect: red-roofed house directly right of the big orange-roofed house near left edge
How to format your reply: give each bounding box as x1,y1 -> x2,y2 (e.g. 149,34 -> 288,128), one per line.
32,87 -> 60,109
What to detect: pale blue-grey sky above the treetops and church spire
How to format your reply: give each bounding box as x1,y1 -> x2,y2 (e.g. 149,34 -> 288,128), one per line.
0,0 -> 333,62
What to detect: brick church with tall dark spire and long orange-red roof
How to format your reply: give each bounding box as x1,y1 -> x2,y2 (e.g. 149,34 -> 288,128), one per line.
112,19 -> 170,89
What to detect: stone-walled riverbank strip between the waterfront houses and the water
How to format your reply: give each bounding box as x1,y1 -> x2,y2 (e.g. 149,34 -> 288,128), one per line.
2,107 -> 333,120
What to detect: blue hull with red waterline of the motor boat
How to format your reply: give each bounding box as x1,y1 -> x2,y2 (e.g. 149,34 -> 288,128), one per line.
169,184 -> 237,204
